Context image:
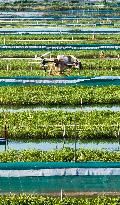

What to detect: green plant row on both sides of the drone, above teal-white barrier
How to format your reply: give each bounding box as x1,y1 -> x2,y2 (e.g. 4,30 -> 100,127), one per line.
0,59 -> 120,73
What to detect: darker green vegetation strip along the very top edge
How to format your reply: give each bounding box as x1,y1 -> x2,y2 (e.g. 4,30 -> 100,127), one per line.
0,0 -> 119,13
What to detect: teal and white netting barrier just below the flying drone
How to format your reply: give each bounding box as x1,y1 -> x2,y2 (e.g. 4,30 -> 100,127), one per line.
0,76 -> 120,86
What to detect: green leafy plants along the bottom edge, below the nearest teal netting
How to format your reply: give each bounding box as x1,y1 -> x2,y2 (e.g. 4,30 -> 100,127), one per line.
0,194 -> 120,205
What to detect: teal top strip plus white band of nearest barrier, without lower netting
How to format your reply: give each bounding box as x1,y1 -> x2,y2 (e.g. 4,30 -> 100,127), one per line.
0,162 -> 120,177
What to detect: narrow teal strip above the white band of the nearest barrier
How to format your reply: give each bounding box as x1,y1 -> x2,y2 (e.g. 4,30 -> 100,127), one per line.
0,162 -> 120,170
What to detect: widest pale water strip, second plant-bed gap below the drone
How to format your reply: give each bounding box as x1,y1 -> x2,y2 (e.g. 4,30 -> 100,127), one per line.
0,140 -> 120,151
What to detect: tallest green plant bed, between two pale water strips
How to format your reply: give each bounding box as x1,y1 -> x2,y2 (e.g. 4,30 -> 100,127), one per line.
0,109 -> 120,140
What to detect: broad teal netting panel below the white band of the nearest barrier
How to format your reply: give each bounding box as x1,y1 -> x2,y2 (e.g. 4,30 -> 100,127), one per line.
0,176 -> 120,193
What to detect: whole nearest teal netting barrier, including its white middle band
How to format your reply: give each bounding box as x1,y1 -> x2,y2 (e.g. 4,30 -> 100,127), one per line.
0,162 -> 120,194
